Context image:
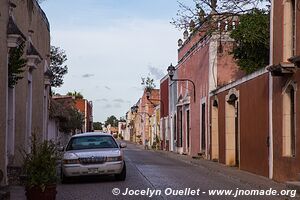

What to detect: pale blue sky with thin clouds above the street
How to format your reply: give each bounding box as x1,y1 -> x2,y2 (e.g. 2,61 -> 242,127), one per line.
41,0 -> 192,122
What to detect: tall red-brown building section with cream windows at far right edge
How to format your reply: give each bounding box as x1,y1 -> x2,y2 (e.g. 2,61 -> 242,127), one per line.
269,0 -> 300,181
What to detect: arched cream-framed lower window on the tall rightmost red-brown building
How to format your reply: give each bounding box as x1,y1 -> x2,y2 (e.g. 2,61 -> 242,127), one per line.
282,85 -> 296,157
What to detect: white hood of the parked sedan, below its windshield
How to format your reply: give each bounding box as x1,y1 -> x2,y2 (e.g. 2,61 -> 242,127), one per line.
64,149 -> 122,159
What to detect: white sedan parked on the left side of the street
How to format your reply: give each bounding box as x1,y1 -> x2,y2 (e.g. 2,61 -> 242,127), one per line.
61,132 -> 126,183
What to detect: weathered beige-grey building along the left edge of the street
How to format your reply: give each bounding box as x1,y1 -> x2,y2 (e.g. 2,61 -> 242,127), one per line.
0,0 -> 50,184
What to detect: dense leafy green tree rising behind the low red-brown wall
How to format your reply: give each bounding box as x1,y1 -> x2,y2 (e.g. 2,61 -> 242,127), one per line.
230,10 -> 270,73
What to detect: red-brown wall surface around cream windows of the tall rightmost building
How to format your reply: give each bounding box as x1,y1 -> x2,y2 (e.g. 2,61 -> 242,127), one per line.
273,0 -> 300,181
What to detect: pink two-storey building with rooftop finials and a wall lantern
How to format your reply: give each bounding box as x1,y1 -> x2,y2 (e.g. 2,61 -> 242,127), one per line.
169,18 -> 243,158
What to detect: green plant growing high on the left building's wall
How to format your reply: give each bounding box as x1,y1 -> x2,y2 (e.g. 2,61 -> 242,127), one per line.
8,42 -> 27,88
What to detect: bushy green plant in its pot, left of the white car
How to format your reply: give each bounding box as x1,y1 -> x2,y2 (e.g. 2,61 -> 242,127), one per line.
23,135 -> 58,200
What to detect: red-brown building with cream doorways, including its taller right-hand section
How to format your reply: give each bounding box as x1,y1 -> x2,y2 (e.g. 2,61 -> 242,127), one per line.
210,0 -> 300,181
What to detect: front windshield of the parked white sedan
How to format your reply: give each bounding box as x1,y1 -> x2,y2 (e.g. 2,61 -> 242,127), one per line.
66,135 -> 118,151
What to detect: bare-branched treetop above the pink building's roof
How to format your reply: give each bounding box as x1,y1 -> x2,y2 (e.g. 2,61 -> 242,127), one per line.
171,0 -> 270,32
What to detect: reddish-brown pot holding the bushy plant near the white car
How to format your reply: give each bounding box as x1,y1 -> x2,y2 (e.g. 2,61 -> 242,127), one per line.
25,185 -> 57,200
